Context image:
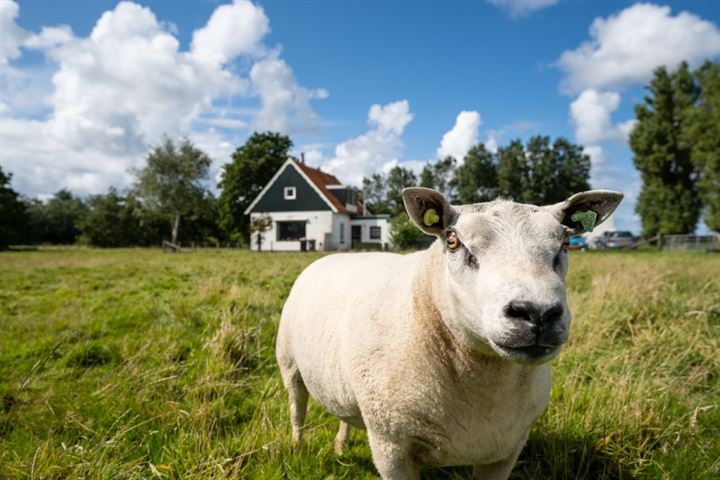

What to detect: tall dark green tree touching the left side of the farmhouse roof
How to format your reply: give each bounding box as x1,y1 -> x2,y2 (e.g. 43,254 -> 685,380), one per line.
218,132 -> 292,239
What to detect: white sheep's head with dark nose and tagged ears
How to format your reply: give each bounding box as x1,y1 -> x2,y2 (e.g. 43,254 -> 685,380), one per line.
403,187 -> 623,363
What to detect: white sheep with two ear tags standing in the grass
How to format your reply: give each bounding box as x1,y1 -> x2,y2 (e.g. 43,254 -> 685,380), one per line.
276,188 -> 622,480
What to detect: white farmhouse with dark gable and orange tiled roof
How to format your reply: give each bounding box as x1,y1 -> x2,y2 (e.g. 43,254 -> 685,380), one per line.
245,159 -> 390,251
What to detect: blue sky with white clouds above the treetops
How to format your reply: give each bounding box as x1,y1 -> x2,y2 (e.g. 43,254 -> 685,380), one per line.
0,0 -> 720,231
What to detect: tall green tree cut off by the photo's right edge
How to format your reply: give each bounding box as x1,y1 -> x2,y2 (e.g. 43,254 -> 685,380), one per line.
687,62 -> 720,232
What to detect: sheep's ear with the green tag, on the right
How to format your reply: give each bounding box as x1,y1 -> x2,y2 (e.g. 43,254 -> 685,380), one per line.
544,190 -> 623,235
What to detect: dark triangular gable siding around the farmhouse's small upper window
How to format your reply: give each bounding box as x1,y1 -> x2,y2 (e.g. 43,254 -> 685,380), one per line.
251,165 -> 332,212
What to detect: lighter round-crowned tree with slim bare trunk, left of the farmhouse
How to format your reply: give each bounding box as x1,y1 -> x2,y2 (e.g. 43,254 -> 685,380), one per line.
135,137 -> 212,243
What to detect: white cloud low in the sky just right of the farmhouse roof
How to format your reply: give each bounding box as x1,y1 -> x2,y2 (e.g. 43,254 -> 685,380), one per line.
323,100 -> 414,185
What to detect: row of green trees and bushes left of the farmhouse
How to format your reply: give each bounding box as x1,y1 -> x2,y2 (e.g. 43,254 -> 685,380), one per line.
0,132 -> 292,249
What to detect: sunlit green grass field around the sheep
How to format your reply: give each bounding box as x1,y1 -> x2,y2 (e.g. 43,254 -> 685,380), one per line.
0,250 -> 720,480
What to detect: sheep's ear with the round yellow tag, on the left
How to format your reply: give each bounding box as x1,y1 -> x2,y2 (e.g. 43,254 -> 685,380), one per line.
402,187 -> 457,237
